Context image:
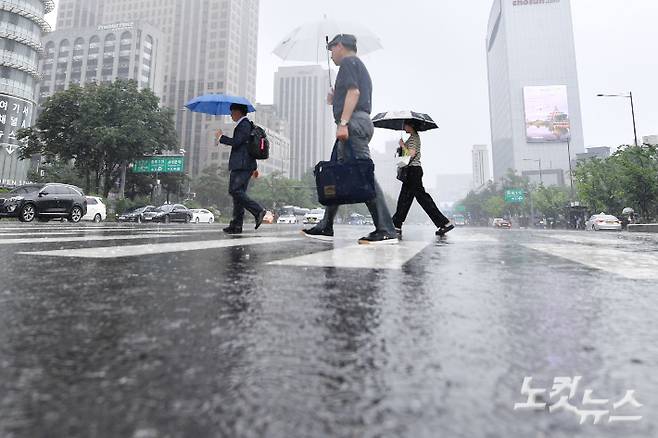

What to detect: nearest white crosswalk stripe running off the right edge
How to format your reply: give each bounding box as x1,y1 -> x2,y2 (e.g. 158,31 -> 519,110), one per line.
523,244 -> 658,280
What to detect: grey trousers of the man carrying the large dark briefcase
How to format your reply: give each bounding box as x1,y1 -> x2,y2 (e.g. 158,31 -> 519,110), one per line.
316,112 -> 395,236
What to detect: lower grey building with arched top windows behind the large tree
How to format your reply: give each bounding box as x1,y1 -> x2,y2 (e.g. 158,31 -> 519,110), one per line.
38,22 -> 164,104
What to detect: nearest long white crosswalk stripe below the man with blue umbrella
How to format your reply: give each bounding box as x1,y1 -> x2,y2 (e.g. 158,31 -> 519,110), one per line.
18,237 -> 302,259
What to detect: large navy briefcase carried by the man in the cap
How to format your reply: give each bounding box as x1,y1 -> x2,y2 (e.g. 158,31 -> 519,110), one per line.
313,141 -> 376,205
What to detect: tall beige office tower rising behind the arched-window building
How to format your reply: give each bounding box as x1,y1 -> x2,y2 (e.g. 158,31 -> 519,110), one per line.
57,0 -> 259,176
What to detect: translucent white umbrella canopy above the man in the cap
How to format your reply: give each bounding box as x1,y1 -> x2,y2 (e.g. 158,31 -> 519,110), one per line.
273,18 -> 382,63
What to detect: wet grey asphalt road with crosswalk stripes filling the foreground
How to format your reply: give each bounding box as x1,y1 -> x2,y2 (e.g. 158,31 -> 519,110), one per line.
0,221 -> 658,438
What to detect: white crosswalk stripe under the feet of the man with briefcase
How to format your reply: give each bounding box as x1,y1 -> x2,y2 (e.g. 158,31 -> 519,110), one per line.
268,242 -> 429,270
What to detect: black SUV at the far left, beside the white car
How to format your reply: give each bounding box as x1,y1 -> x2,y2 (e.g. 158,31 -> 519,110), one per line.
0,184 -> 87,223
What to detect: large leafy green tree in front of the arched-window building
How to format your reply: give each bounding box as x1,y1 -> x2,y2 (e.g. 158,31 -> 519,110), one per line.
18,80 -> 178,196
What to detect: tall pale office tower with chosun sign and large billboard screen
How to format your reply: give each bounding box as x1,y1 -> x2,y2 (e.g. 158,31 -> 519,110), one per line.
486,0 -> 584,185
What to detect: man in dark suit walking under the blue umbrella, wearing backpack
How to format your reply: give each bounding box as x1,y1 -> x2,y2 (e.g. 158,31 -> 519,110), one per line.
216,103 -> 265,234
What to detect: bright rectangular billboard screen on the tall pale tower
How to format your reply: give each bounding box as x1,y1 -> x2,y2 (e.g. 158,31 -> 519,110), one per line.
523,85 -> 571,143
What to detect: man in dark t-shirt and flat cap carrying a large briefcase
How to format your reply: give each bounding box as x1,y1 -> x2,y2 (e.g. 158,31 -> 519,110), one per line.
303,34 -> 398,244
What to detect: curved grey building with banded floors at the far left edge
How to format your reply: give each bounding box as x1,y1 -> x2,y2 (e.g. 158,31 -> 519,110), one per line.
0,0 -> 55,186
